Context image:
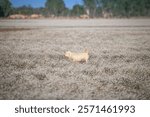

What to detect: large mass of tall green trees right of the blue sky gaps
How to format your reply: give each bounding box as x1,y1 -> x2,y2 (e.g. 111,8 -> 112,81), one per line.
83,0 -> 150,17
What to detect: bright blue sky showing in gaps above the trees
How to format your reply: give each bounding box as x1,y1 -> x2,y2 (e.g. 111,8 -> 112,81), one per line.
11,0 -> 82,8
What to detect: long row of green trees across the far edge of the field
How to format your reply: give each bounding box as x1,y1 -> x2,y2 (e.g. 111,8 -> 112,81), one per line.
0,0 -> 150,17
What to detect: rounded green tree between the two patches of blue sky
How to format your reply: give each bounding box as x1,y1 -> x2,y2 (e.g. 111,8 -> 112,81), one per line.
45,0 -> 65,16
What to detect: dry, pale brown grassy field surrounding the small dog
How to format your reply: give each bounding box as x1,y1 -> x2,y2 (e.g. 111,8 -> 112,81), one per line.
0,19 -> 150,100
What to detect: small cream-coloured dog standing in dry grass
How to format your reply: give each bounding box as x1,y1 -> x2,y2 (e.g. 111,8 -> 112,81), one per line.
65,49 -> 89,63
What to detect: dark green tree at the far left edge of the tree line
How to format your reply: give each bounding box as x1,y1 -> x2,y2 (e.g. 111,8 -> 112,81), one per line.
0,0 -> 11,17
